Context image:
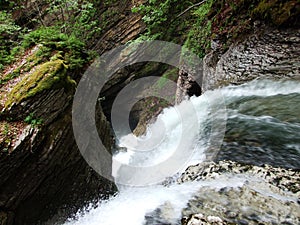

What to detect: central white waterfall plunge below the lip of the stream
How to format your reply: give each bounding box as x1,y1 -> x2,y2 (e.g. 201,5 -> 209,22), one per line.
113,89 -> 225,186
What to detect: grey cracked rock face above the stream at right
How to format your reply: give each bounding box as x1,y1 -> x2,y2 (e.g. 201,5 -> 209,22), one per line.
202,27 -> 300,91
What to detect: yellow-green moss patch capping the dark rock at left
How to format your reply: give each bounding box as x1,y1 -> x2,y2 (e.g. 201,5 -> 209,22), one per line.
5,59 -> 75,108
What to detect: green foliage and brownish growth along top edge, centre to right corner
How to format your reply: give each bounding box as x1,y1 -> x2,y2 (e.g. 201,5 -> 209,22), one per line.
132,0 -> 300,57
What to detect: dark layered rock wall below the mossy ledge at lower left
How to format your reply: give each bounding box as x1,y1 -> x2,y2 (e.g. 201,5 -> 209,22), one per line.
0,60 -> 115,225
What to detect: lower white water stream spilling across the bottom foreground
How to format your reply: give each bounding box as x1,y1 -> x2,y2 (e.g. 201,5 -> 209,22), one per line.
66,177 -> 251,225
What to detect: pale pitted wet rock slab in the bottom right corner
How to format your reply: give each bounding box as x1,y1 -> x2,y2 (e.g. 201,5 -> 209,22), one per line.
146,161 -> 300,225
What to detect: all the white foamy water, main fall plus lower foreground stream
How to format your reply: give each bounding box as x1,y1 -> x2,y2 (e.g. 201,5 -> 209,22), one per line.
65,80 -> 300,225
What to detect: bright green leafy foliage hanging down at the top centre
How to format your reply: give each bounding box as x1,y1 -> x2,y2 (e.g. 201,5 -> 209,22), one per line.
132,0 -> 214,57
